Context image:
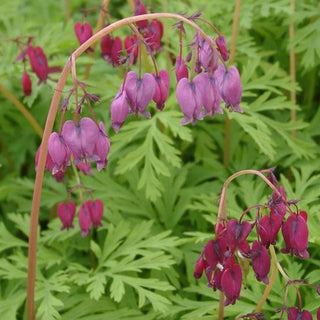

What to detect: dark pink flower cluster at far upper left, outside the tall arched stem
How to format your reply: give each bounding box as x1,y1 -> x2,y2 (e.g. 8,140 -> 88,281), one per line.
16,38 -> 61,96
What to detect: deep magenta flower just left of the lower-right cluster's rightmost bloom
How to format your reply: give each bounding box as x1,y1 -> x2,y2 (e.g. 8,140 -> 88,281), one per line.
257,214 -> 282,248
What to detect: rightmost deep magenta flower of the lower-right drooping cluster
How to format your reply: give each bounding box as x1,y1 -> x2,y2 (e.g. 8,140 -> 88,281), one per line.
281,211 -> 310,259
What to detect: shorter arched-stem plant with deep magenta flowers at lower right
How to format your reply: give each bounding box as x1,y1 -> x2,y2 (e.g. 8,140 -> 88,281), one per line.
194,169 -> 320,320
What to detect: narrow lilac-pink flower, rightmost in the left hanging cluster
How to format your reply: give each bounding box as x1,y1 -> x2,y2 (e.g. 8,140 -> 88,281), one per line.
93,122 -> 110,171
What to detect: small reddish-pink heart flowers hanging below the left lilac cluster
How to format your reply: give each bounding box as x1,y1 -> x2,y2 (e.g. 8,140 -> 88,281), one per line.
58,199 -> 103,237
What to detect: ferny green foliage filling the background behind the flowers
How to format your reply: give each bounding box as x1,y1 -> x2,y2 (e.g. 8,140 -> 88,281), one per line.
0,0 -> 320,320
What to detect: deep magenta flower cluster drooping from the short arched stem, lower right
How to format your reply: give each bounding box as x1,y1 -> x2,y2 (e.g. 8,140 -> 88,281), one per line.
194,170 -> 309,319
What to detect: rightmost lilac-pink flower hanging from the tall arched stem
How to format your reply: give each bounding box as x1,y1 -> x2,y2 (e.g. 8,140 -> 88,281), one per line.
221,66 -> 243,112
